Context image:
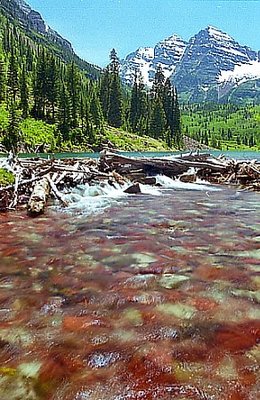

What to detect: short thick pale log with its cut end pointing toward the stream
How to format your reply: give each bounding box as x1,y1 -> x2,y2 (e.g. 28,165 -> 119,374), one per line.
27,177 -> 50,217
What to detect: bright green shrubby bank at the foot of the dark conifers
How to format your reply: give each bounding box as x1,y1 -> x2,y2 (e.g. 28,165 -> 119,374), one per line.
0,105 -> 174,153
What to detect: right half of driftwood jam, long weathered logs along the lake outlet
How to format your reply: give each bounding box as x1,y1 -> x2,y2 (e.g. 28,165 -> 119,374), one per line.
100,153 -> 260,190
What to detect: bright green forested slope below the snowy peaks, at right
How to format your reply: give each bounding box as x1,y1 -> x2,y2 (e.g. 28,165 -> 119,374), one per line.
182,103 -> 260,150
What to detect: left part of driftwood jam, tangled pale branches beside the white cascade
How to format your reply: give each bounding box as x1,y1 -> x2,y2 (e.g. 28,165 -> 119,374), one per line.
0,156 -> 125,216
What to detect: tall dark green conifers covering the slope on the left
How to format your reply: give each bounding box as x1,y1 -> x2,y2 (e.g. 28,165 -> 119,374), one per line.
0,14 -> 182,150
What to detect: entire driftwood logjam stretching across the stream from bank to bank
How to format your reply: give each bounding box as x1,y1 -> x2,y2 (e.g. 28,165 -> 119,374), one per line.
0,151 -> 260,216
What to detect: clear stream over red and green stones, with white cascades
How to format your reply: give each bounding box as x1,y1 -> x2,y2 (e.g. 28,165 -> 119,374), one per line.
0,177 -> 260,400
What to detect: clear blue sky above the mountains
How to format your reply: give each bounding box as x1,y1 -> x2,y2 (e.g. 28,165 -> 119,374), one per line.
27,0 -> 260,66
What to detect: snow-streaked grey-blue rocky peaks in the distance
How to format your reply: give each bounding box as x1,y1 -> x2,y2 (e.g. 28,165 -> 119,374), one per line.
121,26 -> 260,102
